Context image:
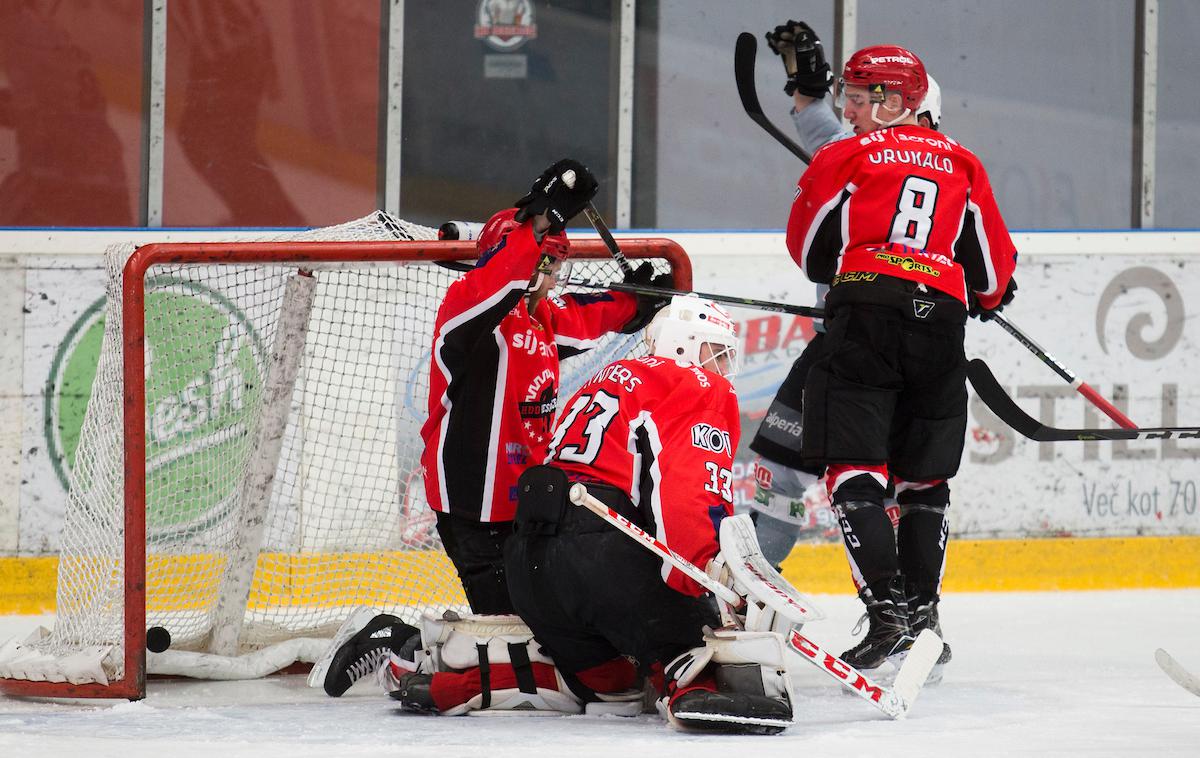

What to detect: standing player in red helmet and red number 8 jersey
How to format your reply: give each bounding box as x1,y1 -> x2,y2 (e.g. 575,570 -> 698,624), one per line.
787,46 -> 1016,669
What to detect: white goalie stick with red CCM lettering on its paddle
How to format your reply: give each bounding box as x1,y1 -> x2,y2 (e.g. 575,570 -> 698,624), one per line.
570,483 -> 942,718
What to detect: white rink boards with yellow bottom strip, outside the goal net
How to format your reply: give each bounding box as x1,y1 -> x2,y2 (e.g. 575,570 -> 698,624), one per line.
0,225 -> 1200,612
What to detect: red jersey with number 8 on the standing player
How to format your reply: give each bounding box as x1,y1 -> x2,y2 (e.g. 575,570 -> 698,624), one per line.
787,126 -> 1016,308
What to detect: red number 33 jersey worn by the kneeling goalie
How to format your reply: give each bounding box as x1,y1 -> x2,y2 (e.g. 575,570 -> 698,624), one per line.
546,356 -> 740,596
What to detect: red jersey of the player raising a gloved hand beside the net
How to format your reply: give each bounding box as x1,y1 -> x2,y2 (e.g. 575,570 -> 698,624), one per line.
421,223 -> 637,522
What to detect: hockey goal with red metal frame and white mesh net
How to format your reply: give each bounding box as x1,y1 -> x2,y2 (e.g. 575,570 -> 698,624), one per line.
0,211 -> 691,698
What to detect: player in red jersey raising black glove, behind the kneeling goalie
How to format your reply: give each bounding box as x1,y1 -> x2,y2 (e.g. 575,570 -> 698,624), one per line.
421,160 -> 662,613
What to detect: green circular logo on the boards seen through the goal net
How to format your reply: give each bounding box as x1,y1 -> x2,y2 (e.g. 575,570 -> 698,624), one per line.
44,277 -> 265,535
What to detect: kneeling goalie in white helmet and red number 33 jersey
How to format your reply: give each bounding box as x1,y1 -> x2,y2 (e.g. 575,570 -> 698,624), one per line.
383,296 -> 792,733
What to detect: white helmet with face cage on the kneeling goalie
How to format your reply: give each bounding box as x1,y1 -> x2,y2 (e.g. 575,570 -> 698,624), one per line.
646,295 -> 738,379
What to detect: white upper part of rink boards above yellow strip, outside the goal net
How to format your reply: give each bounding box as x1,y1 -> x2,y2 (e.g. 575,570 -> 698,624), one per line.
0,225 -> 1200,554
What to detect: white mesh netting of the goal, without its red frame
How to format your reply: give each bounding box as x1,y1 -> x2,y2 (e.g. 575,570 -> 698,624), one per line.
0,211 -> 667,679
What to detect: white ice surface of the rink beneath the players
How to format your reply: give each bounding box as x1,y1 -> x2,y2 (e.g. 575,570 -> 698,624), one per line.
0,590 -> 1200,758
